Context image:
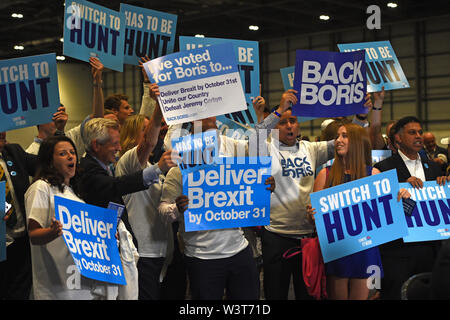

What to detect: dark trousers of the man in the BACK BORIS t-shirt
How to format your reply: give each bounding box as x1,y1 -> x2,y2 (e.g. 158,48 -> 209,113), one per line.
261,228 -> 313,300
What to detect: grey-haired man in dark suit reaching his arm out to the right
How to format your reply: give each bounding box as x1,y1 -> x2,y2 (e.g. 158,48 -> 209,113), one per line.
78,112 -> 176,246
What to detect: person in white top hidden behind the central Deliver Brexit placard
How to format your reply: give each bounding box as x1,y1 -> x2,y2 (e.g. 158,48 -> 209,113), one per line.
159,90 -> 296,300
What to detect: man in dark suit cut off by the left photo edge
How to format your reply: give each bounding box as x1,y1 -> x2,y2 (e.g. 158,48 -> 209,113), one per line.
0,132 -> 37,300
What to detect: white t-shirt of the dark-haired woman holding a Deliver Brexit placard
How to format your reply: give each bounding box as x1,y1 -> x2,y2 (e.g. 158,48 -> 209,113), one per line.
25,180 -> 115,300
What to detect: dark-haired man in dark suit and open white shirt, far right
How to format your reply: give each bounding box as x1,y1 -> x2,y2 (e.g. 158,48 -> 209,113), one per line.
374,116 -> 446,299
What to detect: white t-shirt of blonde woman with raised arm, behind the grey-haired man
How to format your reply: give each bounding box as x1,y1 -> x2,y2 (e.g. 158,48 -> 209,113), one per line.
116,147 -> 171,258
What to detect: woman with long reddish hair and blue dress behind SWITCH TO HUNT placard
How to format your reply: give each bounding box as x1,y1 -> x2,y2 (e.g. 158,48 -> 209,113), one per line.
307,123 -> 409,300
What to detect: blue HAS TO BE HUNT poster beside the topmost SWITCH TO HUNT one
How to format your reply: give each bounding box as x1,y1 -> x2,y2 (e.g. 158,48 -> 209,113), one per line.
120,3 -> 177,66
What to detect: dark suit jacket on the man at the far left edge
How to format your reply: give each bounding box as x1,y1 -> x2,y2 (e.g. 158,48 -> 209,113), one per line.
2,143 -> 37,228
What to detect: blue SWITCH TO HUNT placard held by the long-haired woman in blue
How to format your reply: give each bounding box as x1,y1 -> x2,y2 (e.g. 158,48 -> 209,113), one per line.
311,170 -> 408,262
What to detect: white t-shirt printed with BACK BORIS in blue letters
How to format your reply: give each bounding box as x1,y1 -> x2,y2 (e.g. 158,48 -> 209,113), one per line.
265,139 -> 334,237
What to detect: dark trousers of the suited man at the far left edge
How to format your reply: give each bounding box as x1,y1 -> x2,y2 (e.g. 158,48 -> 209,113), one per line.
0,236 -> 32,300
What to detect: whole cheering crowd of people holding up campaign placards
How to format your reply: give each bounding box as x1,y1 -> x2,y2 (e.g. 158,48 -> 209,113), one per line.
0,58 -> 450,300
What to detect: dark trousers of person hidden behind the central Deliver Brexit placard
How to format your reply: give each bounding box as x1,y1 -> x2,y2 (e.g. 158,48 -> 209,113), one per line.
185,246 -> 259,300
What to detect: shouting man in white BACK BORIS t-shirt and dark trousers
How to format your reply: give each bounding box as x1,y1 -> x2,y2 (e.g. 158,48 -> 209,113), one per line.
262,104 -> 334,300
